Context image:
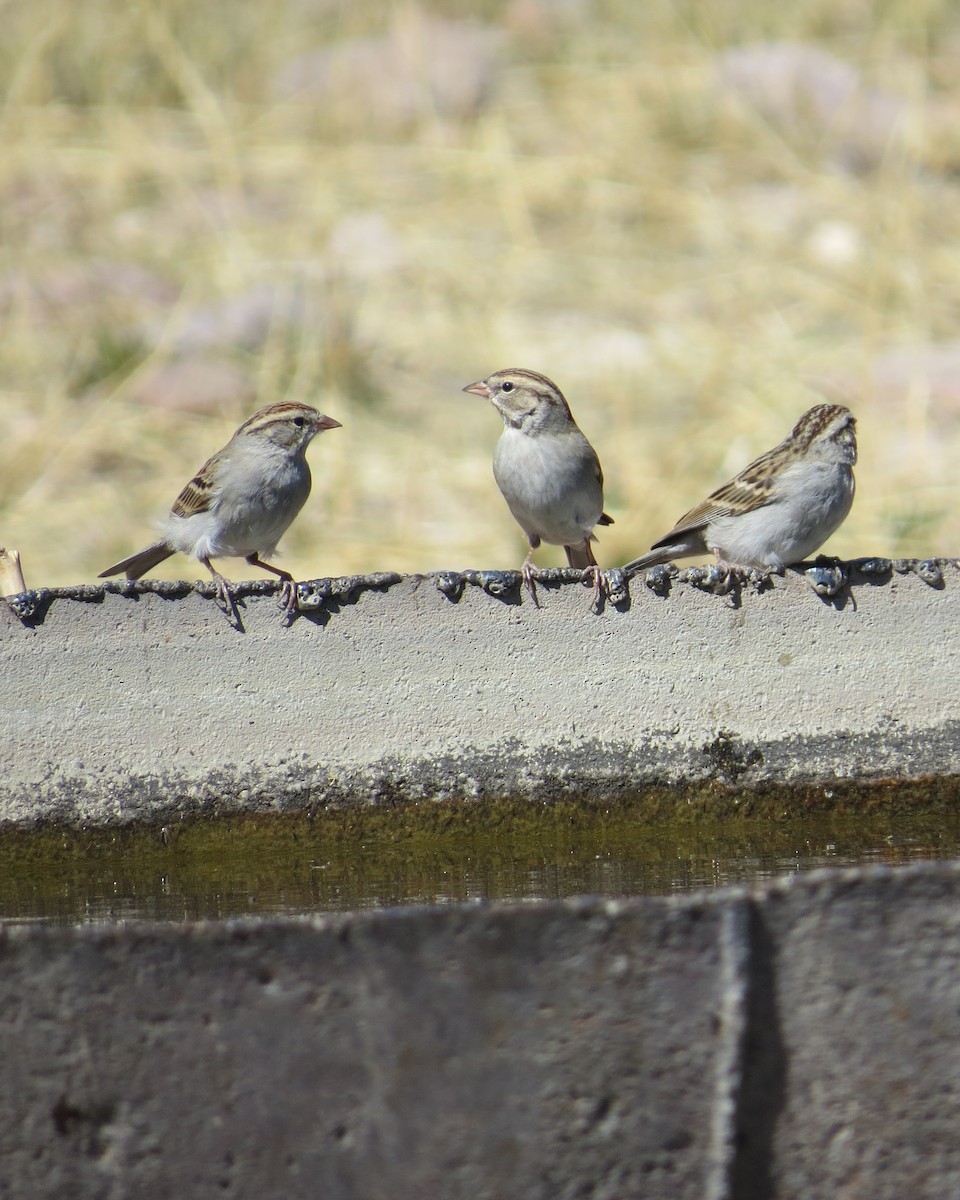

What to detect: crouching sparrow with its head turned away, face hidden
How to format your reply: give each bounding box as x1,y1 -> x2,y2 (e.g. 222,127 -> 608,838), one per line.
624,404 -> 857,575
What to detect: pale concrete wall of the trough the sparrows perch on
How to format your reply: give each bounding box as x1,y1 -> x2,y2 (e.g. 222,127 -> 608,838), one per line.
0,560 -> 960,823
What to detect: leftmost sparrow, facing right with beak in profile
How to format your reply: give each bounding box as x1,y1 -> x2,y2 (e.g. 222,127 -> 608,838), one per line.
100,401 -> 340,616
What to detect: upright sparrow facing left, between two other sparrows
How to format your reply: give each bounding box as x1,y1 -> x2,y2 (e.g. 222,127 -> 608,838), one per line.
463,367 -> 613,602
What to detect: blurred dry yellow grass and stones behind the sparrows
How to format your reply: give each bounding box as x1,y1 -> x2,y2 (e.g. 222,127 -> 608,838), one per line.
0,0 -> 960,586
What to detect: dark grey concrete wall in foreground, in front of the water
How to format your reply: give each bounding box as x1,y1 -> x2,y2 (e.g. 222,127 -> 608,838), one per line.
0,864 -> 960,1200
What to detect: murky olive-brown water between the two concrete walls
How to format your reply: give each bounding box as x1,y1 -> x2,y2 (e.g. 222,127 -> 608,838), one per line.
0,804 -> 960,925
